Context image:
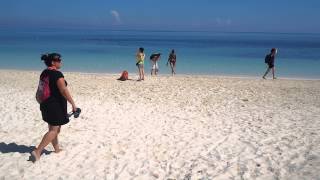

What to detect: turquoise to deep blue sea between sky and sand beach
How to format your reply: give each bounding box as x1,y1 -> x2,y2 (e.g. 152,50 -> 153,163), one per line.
0,29 -> 320,79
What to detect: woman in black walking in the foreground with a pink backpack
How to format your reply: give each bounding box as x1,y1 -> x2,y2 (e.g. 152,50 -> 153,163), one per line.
31,53 -> 77,161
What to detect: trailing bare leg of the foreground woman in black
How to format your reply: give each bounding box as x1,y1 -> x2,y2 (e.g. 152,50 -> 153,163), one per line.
32,125 -> 60,161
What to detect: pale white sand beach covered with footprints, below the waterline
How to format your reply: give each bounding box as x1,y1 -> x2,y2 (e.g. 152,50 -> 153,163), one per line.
0,70 -> 320,180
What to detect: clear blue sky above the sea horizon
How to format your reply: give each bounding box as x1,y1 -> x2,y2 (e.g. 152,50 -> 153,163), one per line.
0,0 -> 320,33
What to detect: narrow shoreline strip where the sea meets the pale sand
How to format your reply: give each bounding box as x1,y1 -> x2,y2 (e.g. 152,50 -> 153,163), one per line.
0,68 -> 320,81
